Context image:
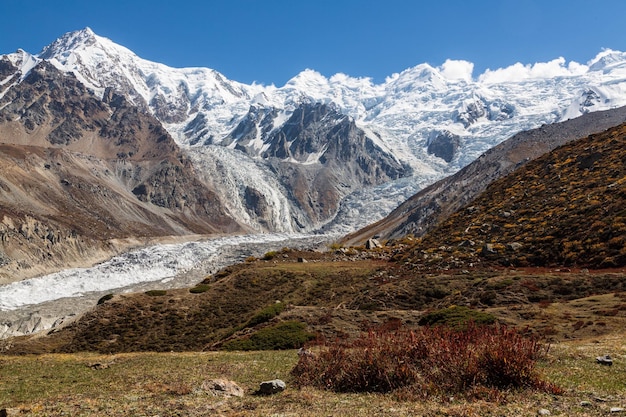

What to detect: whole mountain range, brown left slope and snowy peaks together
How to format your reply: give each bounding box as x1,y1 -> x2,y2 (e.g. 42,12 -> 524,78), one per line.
0,28 -> 626,280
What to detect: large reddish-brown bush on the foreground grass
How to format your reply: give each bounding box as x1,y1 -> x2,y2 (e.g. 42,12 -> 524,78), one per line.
292,324 -> 561,397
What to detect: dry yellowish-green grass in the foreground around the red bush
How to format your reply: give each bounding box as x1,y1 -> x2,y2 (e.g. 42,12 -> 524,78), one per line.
0,332 -> 626,417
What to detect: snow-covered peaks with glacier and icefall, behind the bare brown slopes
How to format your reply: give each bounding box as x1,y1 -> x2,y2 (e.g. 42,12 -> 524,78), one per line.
0,28 -> 626,232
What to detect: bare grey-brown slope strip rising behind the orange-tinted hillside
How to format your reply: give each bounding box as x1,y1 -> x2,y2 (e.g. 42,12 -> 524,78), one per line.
342,107 -> 626,245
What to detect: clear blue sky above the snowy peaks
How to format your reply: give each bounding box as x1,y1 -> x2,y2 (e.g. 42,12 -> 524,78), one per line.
0,0 -> 626,86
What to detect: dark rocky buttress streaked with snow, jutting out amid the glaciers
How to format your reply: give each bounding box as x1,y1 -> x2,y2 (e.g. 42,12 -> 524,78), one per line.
219,101 -> 411,230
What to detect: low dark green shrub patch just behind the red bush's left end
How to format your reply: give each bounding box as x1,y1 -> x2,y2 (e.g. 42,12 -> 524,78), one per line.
223,321 -> 315,350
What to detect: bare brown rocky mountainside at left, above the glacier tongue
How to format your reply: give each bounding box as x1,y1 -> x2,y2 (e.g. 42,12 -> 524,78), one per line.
0,58 -> 242,283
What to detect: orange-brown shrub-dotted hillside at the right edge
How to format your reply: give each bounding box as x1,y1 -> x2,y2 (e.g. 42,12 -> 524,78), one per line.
400,124 -> 626,268
